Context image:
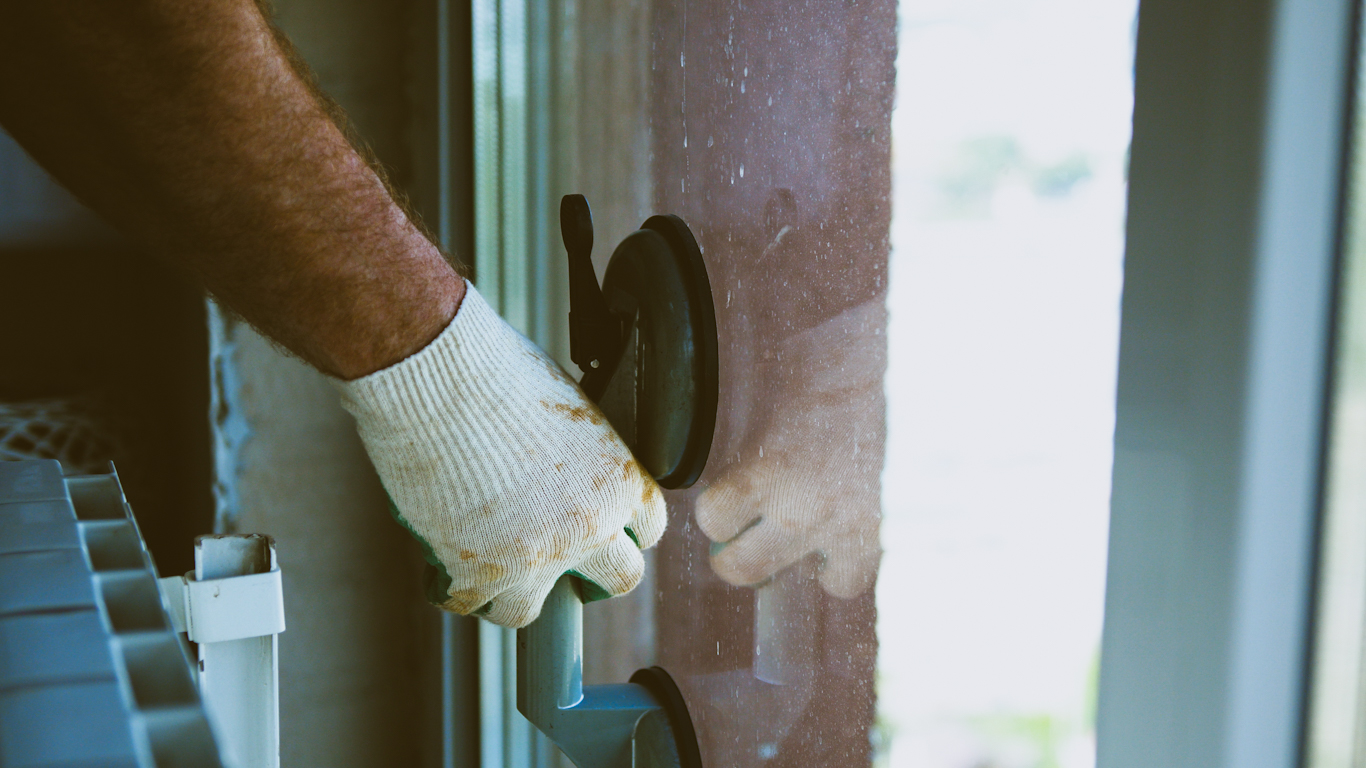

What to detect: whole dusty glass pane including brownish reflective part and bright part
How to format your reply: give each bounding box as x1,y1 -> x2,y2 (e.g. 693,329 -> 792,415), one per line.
572,0 -> 1134,768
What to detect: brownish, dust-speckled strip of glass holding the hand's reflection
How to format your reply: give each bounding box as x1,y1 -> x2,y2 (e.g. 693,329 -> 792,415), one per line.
636,0 -> 896,765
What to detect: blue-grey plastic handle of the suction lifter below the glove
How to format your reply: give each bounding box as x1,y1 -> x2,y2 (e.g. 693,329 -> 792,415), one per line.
516,575 -> 679,768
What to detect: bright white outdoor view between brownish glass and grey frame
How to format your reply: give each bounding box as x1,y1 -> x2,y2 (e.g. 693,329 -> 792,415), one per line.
878,0 -> 1135,768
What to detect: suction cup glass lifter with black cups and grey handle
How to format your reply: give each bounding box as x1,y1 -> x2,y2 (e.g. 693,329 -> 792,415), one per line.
516,194 -> 719,768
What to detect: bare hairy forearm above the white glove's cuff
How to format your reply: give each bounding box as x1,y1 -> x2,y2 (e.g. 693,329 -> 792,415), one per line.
0,0 -> 464,379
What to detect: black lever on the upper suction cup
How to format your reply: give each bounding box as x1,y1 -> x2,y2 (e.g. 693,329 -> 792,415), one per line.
560,194 -> 626,373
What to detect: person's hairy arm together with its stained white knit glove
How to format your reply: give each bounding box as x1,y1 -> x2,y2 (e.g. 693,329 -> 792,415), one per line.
0,0 -> 668,626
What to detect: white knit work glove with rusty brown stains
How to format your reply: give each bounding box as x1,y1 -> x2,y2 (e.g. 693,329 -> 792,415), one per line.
336,286 -> 665,627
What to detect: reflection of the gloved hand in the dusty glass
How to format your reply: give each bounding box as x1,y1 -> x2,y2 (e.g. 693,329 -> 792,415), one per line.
697,301 -> 887,597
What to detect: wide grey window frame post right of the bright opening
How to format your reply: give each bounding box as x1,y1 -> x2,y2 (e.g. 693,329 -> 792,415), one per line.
1097,0 -> 1354,768
